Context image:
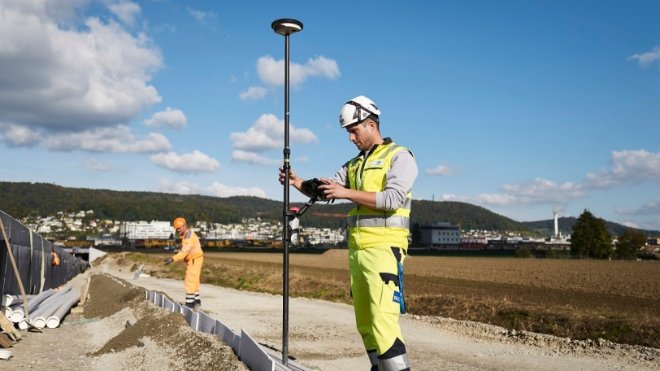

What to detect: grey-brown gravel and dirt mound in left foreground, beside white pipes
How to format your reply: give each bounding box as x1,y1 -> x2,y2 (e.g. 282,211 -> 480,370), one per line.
0,274 -> 247,371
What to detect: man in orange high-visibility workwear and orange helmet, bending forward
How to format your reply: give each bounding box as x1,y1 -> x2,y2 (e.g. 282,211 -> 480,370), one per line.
164,217 -> 204,308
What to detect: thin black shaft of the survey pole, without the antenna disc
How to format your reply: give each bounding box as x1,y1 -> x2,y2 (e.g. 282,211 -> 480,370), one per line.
282,34 -> 291,366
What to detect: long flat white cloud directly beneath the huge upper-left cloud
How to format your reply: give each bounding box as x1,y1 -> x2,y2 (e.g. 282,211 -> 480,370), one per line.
42,126 -> 170,153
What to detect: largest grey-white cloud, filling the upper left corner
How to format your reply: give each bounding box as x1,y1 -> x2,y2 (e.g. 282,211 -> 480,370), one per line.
0,0 -> 162,131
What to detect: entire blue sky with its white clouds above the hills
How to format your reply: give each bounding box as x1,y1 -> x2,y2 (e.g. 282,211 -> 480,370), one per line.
0,0 -> 660,230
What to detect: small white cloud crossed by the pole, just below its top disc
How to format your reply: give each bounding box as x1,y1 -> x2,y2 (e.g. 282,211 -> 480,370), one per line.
257,55 -> 340,86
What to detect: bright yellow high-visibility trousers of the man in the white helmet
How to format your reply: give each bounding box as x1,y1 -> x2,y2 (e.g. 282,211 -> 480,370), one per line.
348,246 -> 405,356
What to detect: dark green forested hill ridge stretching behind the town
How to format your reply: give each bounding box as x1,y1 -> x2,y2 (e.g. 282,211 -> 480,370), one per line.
0,182 -> 656,235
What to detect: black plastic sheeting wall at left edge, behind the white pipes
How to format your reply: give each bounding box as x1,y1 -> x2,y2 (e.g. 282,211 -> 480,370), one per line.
0,211 -> 89,295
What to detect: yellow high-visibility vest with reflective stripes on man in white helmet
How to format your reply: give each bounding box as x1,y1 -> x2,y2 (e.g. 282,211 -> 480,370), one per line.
347,142 -> 412,249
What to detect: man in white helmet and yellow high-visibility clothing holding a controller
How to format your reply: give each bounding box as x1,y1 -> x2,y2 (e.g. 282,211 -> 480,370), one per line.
279,95 -> 418,371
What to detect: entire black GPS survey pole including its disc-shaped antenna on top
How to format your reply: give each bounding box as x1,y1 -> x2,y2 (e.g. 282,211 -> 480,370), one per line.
271,18 -> 303,366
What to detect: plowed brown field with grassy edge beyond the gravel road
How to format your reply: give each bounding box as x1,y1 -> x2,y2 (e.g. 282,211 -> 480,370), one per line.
127,250 -> 660,348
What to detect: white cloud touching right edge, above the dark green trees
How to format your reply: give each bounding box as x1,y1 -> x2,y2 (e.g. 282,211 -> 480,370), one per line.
584,149 -> 660,189
